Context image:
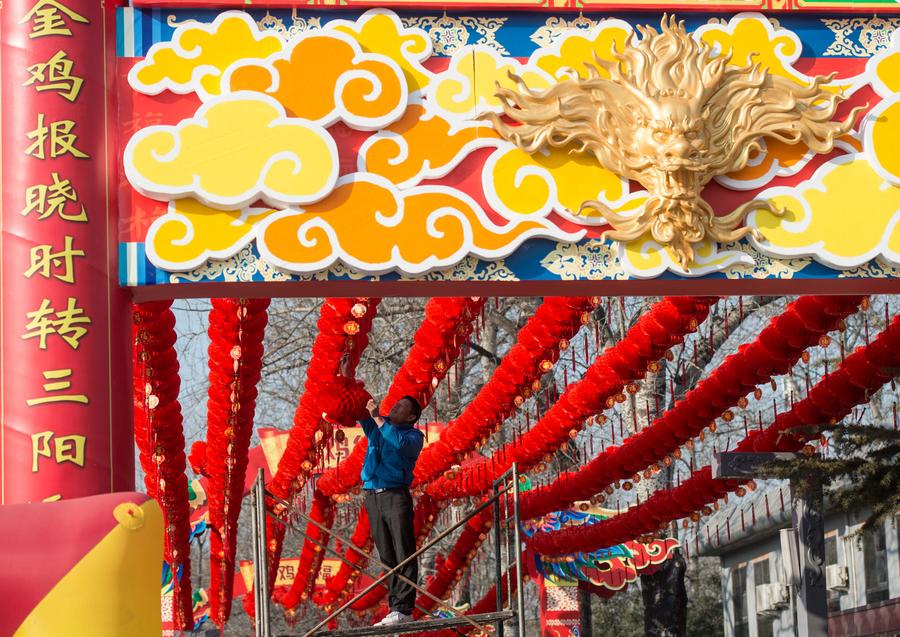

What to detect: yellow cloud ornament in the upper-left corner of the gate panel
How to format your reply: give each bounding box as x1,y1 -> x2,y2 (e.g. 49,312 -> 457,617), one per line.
128,11 -> 284,100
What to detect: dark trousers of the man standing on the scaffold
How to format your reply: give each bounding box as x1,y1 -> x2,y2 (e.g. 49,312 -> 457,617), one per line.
366,487 -> 419,615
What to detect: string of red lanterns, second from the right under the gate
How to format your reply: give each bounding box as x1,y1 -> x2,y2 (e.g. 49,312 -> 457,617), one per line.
522,296 -> 863,519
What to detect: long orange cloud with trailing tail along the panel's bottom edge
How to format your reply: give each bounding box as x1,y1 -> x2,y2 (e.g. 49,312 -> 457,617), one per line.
257,173 -> 583,274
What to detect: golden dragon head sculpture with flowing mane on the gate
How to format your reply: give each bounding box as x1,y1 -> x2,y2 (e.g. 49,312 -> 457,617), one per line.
484,17 -> 861,268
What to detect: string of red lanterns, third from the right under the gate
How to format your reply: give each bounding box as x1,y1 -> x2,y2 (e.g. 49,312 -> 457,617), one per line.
426,297 -> 717,498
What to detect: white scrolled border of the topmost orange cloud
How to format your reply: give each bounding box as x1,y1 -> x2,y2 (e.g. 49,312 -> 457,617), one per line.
222,29 -> 409,131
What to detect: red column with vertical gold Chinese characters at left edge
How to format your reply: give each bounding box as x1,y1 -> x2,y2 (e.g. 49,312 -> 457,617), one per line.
0,0 -> 134,504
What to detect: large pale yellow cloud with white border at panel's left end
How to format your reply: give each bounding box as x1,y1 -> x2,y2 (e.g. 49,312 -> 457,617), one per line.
124,92 -> 338,209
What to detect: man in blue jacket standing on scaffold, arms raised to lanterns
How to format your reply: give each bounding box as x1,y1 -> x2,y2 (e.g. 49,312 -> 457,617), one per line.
360,396 -> 425,626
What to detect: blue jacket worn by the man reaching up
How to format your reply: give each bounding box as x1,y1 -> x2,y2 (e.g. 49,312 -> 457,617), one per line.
359,418 -> 425,489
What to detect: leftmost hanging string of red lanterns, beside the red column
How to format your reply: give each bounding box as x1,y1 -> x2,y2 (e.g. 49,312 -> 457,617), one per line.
131,300 -> 194,631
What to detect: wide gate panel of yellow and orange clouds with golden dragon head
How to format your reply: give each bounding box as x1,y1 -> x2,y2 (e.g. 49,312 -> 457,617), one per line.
123,9 -> 900,281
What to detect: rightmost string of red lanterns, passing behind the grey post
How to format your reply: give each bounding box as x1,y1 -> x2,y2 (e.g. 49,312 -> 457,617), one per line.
529,317 -> 900,555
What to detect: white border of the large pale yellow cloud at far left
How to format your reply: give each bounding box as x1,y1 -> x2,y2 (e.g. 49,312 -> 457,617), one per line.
122,91 -> 340,210
